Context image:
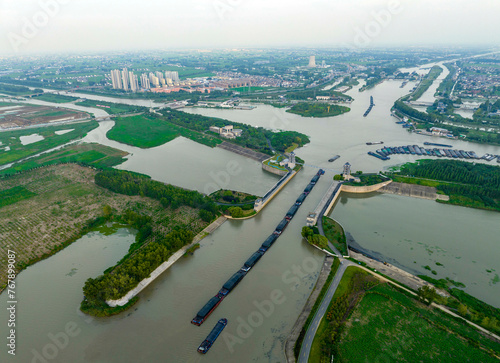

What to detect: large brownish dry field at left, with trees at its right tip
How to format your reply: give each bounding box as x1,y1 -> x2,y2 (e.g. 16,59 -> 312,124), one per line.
0,164 -> 207,292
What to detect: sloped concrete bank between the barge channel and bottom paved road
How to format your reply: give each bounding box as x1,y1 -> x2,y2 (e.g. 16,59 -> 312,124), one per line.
284,256 -> 334,363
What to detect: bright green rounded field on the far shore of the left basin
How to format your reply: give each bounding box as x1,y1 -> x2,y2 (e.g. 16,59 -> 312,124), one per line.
107,115 -> 222,149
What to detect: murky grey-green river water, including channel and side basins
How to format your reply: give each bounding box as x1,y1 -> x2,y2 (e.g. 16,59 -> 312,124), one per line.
0,68 -> 500,363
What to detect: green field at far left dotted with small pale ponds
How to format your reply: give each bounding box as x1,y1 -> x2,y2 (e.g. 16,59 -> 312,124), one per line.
0,121 -> 98,165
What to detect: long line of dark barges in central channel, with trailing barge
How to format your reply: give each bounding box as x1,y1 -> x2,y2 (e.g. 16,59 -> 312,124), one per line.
191,169 -> 325,354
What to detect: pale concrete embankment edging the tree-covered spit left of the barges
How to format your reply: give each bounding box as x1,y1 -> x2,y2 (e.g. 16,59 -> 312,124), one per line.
106,217 -> 227,307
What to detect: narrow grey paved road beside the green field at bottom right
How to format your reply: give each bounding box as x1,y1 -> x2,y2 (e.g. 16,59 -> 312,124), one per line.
298,260 -> 356,363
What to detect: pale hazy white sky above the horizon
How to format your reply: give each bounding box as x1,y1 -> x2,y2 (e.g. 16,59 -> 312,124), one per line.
0,0 -> 500,54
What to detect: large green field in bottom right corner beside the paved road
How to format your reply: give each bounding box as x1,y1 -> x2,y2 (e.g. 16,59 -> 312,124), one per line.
309,267 -> 500,363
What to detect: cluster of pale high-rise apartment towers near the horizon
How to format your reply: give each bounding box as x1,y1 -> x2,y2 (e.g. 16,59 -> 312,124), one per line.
111,68 -> 180,92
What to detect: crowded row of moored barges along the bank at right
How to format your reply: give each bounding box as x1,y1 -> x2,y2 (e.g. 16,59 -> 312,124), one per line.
368,145 -> 496,161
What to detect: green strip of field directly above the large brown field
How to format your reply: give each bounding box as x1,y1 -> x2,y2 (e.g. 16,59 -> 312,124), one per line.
0,144 -> 127,176
